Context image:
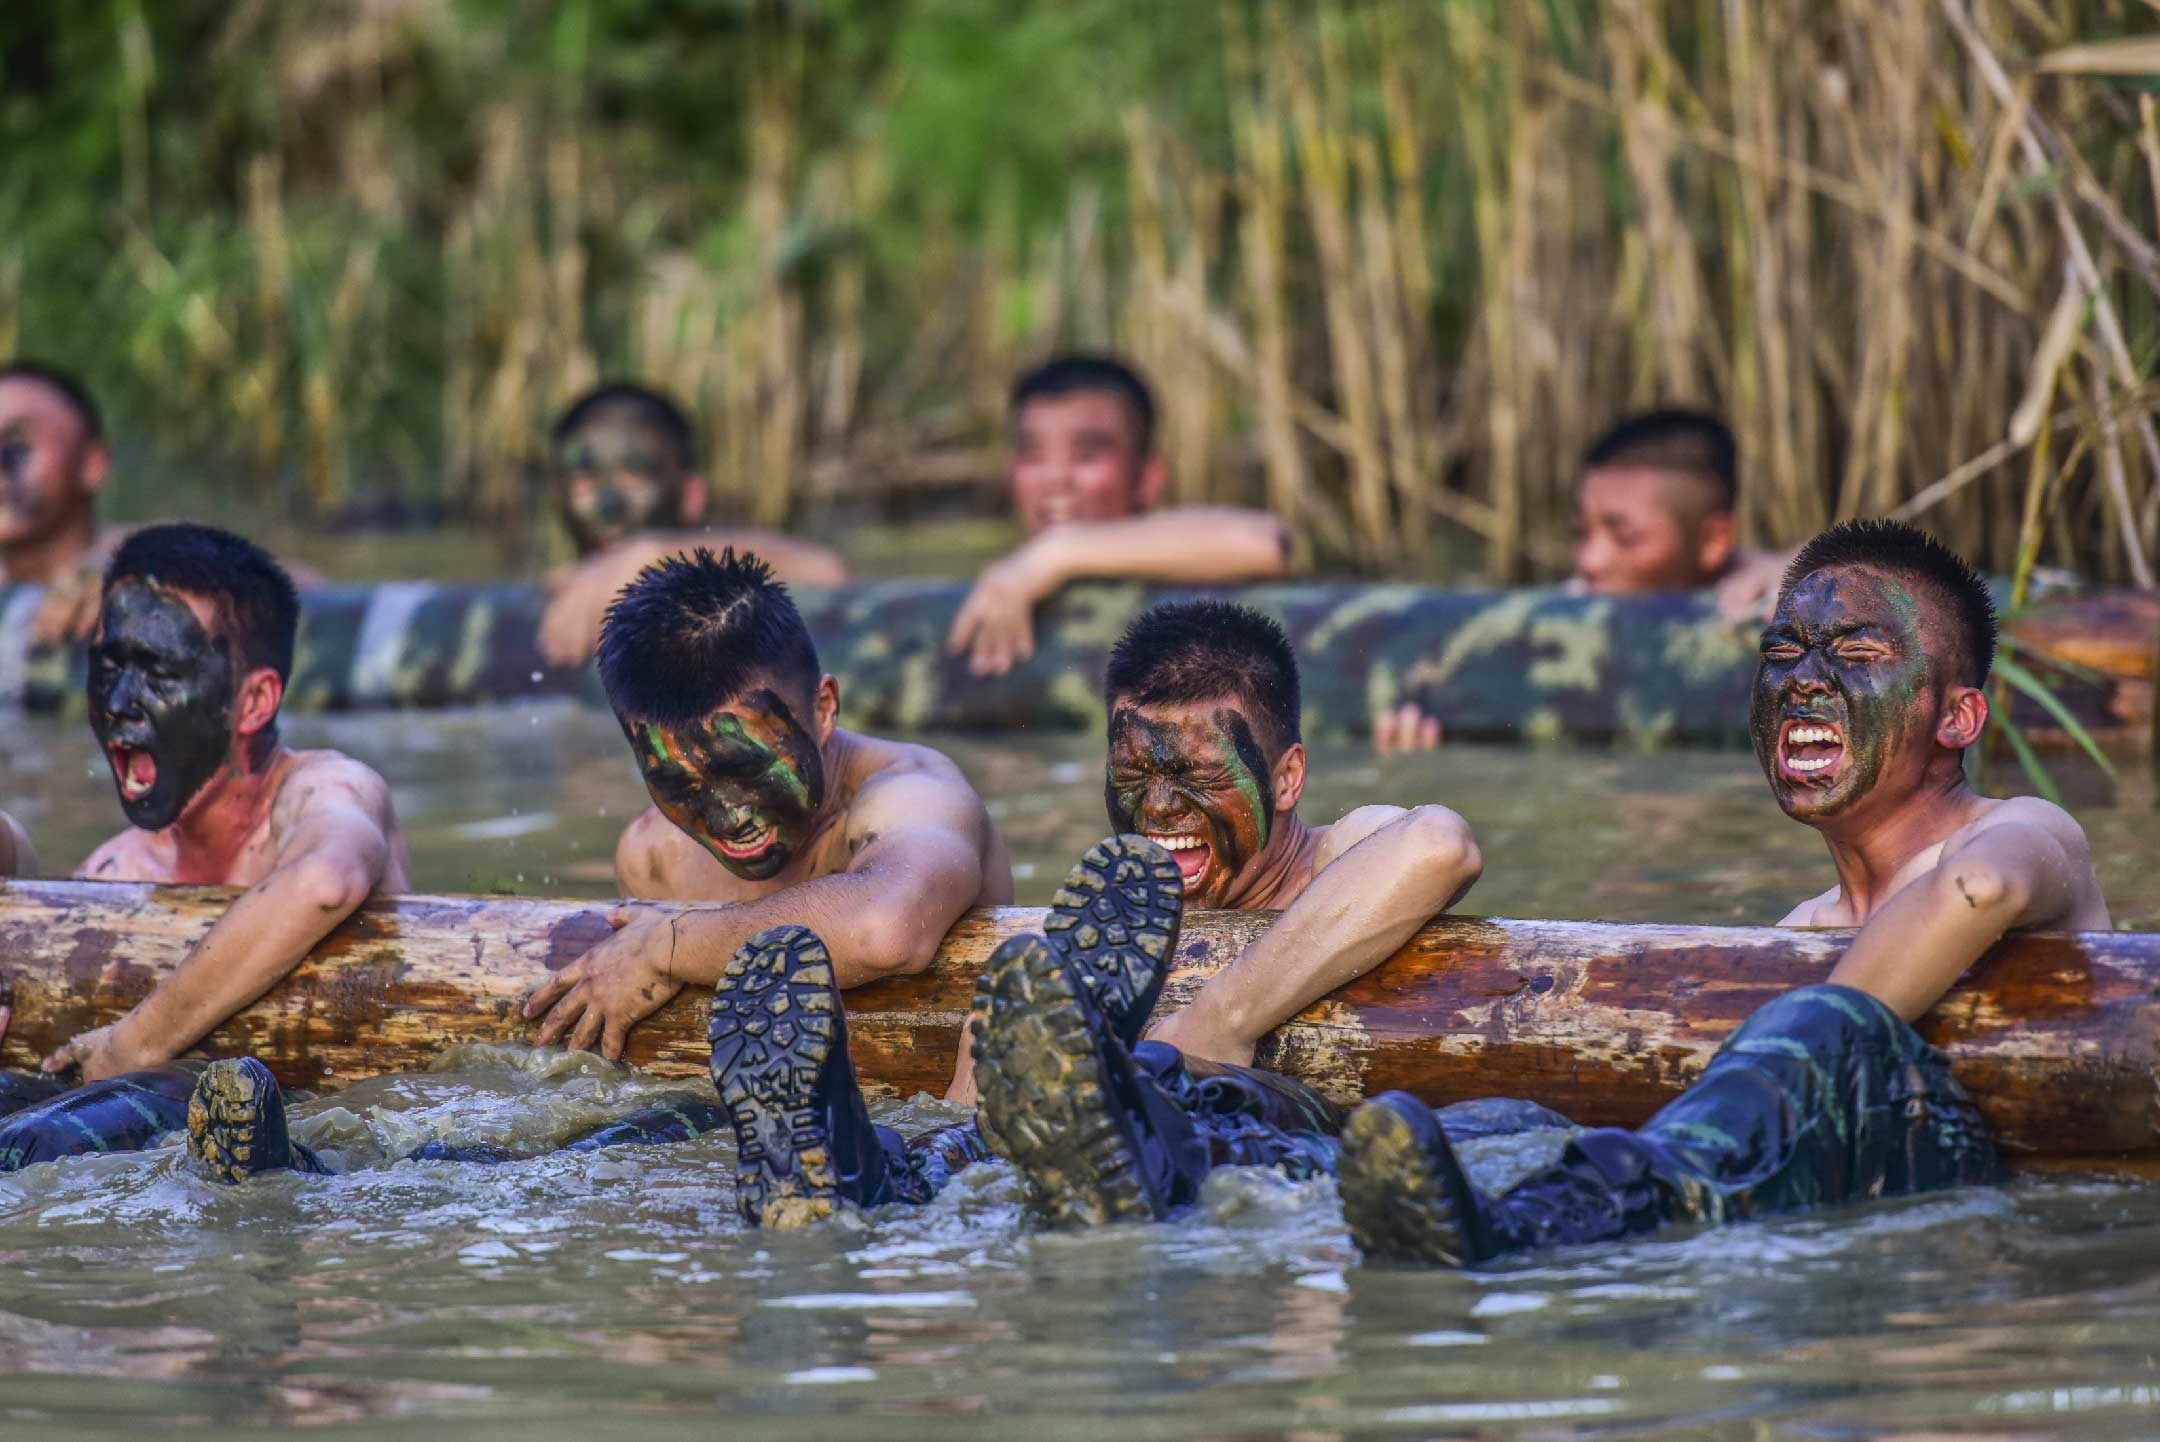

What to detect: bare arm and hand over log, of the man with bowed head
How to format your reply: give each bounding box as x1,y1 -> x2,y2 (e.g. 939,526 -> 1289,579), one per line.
525,756 -> 996,1060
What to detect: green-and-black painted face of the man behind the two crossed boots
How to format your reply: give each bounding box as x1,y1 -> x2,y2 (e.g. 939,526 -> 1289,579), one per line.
1104,706 -> 1274,907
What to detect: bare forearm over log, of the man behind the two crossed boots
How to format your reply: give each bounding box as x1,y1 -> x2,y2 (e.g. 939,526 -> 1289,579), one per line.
1151,805 -> 1484,1066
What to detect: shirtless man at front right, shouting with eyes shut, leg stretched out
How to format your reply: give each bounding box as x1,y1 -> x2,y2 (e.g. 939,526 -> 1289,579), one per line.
1341,522 -> 2108,1267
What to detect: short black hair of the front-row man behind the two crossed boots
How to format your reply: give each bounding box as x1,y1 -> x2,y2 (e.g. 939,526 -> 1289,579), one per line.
1102,600 -> 1302,756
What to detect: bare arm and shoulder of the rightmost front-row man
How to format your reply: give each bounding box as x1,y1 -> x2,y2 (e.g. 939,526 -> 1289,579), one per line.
1830,797 -> 2110,1021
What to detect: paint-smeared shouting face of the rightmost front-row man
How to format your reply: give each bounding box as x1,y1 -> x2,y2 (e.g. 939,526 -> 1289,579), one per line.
1747,568 -> 1938,822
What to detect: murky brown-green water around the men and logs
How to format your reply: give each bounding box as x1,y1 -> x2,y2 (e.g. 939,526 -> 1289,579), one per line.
0,708 -> 2160,1442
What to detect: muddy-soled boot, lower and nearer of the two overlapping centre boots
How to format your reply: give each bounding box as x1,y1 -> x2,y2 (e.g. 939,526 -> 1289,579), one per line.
974,935 -> 1207,1226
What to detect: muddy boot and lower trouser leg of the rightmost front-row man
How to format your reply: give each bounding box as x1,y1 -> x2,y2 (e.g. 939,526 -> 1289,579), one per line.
1341,1092 -> 1676,1267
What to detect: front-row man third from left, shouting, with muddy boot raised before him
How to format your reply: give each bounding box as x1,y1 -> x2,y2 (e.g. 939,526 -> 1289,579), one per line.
950,600 -> 1503,1226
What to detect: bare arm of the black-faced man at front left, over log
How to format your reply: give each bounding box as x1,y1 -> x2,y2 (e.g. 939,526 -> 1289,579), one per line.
45,753 -> 404,1082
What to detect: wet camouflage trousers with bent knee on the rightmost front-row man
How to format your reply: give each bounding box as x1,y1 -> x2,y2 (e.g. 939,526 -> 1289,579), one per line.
1499,984 -> 2002,1241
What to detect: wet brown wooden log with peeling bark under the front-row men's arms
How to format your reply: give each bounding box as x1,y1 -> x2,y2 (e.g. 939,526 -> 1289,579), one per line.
0,881 -> 2160,1159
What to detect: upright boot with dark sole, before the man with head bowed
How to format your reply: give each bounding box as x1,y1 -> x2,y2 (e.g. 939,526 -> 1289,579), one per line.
708,926 -> 896,1228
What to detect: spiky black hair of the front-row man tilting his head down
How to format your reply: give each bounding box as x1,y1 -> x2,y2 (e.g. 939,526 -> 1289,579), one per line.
600,546 -> 819,725
